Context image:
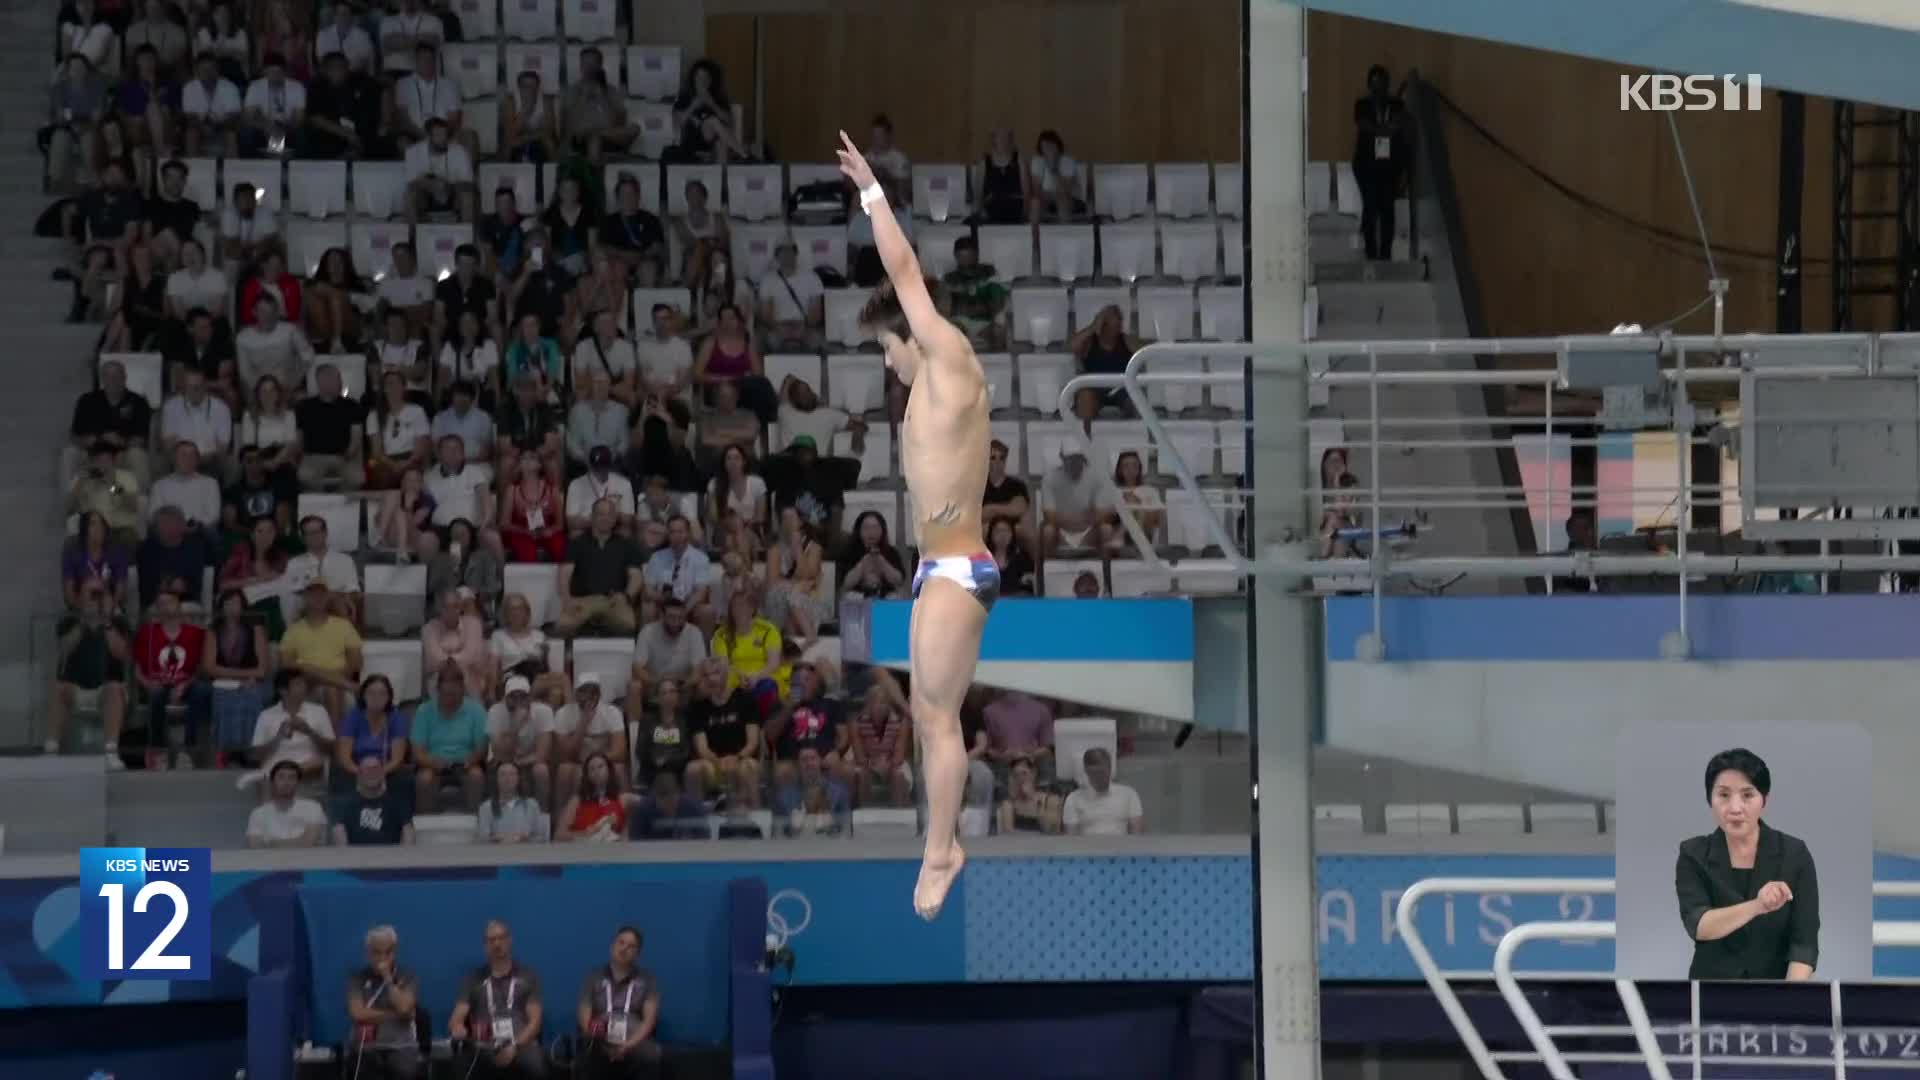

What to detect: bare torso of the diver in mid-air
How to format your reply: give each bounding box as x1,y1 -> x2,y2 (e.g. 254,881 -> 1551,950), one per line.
900,332 -> 989,559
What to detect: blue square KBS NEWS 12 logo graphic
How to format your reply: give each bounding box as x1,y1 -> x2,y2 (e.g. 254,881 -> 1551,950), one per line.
81,847 -> 213,982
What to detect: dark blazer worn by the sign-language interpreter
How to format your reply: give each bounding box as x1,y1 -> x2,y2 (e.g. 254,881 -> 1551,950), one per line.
1674,821 -> 1820,978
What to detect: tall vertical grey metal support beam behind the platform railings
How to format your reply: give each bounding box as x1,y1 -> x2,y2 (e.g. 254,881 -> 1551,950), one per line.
1244,0 -> 1321,1080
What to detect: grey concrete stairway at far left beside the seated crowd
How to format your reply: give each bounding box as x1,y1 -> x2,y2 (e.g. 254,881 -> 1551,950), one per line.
0,0 -> 100,748
